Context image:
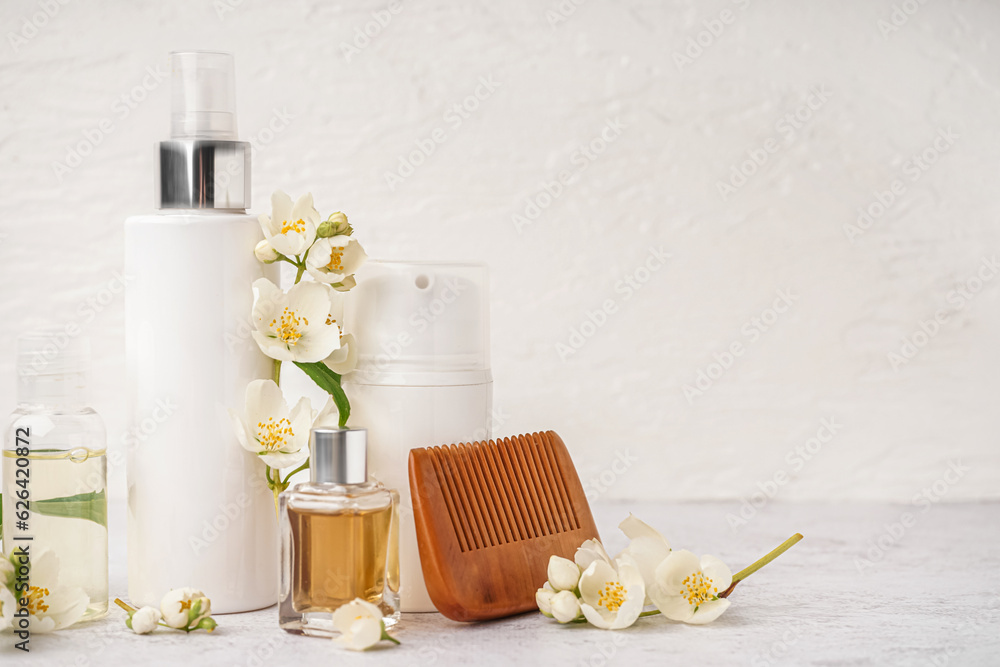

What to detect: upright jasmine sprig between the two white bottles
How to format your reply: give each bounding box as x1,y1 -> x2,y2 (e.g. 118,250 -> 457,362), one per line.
230,190 -> 368,511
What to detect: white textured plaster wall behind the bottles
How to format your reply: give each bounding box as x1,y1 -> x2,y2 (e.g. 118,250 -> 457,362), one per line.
0,0 -> 1000,501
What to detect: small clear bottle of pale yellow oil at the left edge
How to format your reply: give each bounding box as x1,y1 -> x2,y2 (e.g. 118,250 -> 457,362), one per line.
3,329 -> 108,621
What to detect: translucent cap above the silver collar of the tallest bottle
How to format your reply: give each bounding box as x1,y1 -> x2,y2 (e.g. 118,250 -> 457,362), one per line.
170,51 -> 237,141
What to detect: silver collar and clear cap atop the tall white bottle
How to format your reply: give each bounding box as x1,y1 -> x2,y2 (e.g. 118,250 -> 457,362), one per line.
155,51 -> 250,210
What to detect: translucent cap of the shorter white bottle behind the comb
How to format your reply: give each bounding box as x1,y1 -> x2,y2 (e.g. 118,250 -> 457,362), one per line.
344,261 -> 490,385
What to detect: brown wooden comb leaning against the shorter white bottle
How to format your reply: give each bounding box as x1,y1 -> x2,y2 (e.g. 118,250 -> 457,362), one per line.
409,431 -> 599,621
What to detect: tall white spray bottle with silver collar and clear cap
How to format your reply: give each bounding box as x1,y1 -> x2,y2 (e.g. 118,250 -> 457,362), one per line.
125,52 -> 278,613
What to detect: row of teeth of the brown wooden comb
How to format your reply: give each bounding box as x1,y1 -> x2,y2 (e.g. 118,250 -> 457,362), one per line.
427,433 -> 580,552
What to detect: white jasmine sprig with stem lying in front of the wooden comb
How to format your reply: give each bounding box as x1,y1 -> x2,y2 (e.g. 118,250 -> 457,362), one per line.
535,514 -> 802,630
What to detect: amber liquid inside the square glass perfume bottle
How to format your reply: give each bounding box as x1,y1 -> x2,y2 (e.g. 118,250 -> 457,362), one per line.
288,505 -> 392,613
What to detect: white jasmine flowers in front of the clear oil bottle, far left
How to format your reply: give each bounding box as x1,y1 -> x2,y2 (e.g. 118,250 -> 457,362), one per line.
0,550 -> 90,633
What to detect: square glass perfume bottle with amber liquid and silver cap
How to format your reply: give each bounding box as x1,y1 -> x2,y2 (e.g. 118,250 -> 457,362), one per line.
278,428 -> 399,637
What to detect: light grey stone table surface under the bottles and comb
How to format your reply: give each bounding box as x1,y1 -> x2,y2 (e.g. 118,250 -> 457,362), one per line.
0,502 -> 1000,667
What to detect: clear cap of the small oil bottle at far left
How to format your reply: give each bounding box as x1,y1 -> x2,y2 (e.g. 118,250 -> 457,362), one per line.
17,327 -> 90,403
